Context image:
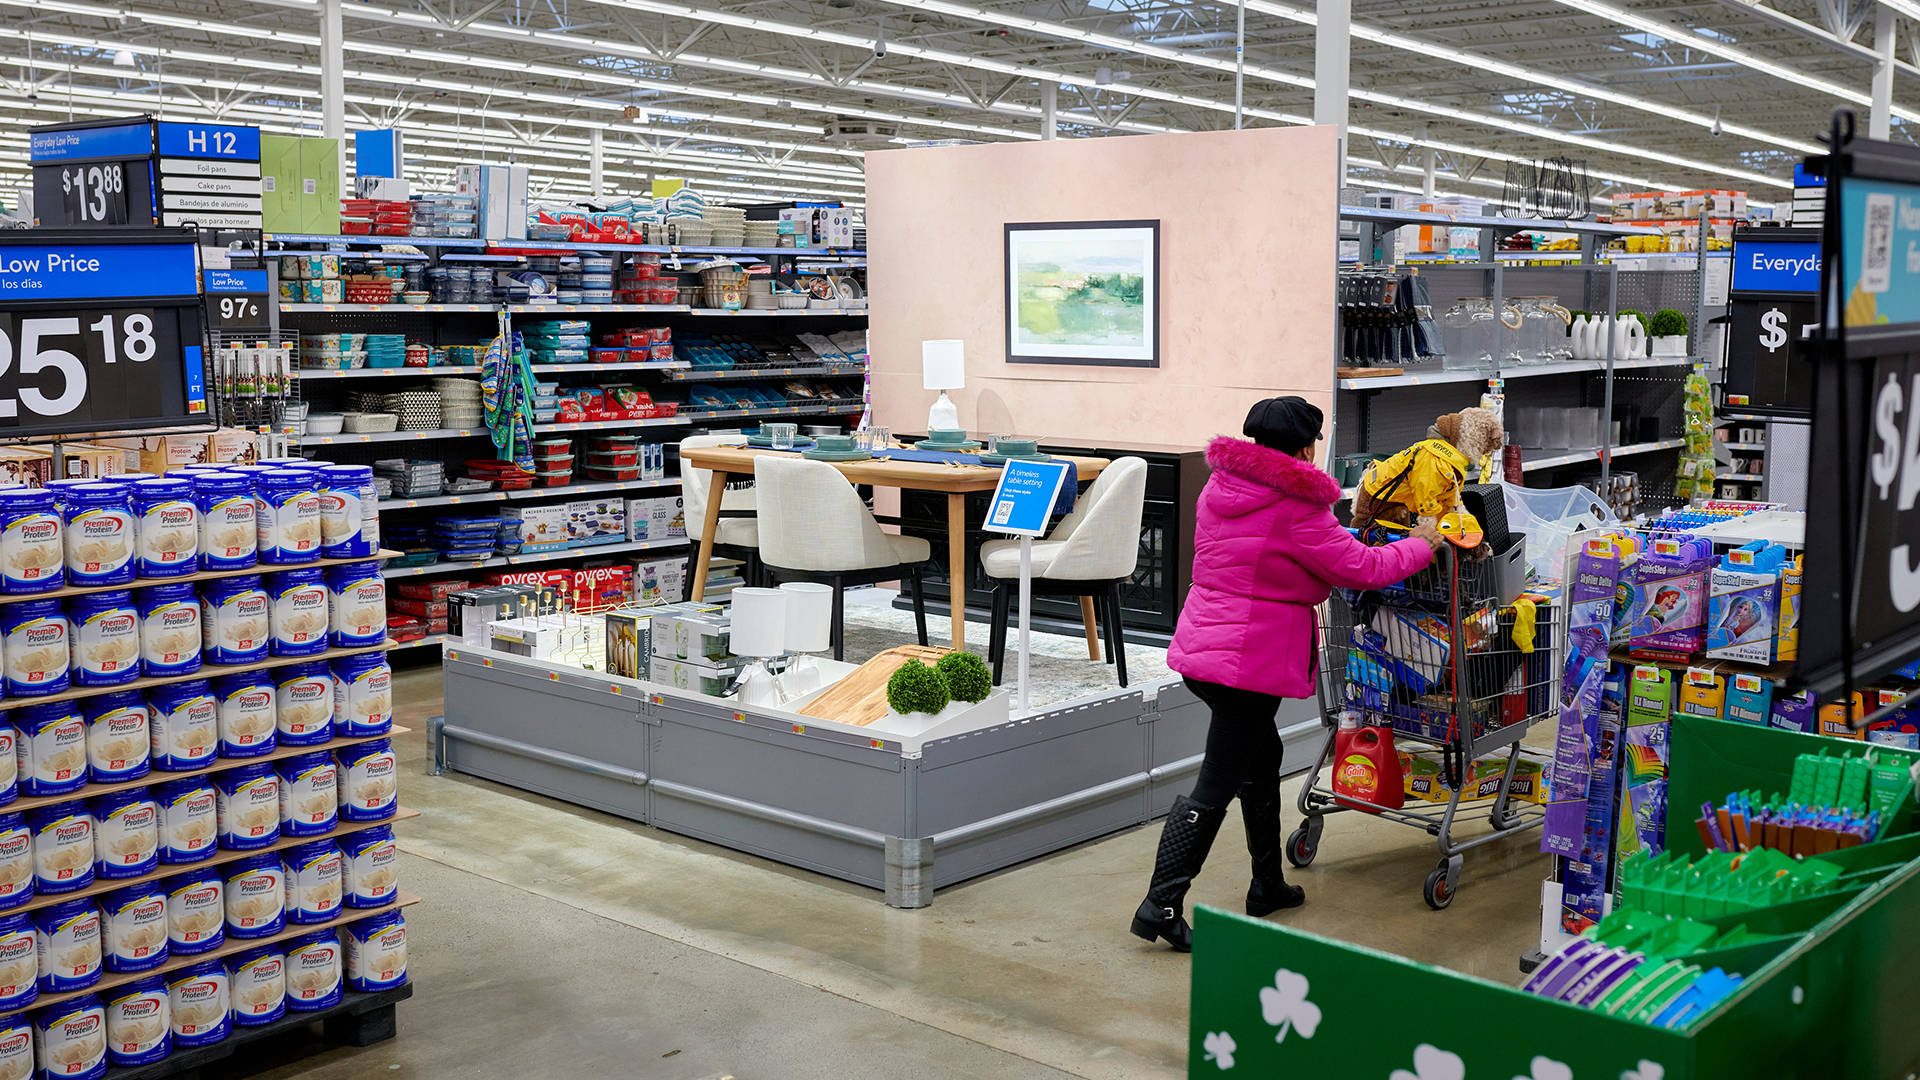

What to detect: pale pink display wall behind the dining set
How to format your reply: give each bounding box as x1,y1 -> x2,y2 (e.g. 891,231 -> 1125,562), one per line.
866,127 -> 1338,444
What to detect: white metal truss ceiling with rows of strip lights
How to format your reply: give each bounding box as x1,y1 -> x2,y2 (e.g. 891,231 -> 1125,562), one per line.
0,0 -> 1920,204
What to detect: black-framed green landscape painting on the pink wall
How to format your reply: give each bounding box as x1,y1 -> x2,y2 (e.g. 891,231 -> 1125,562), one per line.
1006,219 -> 1160,367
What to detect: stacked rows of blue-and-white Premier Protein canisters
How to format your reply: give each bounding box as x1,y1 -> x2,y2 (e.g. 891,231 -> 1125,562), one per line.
0,459 -> 405,1078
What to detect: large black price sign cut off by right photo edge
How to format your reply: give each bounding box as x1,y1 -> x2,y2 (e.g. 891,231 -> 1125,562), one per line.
1795,122 -> 1920,700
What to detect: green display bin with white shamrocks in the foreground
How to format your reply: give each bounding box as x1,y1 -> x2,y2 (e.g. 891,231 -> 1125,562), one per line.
1187,717 -> 1920,1080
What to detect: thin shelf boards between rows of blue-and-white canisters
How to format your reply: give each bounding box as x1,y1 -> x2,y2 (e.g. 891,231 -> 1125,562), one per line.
0,550 -> 420,1076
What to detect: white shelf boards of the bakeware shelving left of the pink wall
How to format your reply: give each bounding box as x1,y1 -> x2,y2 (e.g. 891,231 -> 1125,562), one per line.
265,233 -> 866,626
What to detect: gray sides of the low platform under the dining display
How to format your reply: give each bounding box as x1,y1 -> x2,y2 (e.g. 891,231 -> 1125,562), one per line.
428,648 -> 1323,907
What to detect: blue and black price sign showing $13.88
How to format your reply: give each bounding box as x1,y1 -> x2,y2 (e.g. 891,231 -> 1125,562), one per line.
27,115 -> 154,229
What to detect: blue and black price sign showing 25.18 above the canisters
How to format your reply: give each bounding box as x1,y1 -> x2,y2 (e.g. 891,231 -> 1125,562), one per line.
0,229 -> 207,438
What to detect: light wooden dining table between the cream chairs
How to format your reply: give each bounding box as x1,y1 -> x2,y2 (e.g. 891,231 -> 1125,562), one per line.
680,446 -> 1108,650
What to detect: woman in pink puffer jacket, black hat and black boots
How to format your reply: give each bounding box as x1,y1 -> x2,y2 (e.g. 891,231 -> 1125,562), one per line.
1133,398 -> 1442,953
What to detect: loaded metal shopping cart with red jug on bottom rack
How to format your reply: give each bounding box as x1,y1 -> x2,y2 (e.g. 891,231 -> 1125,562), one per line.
1286,534 -> 1563,899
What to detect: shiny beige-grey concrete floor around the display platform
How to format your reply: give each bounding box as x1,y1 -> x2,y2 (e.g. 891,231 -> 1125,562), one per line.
266,653 -> 1546,1080
